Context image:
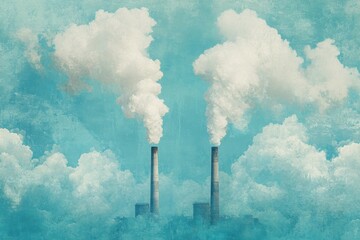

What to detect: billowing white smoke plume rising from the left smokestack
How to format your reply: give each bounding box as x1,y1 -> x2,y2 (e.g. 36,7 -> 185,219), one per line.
54,8 -> 168,143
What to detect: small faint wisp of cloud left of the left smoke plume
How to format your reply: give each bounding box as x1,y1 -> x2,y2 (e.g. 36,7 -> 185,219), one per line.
16,28 -> 43,71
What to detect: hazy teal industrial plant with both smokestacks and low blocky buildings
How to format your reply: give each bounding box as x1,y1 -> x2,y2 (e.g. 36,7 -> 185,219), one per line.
113,146 -> 266,239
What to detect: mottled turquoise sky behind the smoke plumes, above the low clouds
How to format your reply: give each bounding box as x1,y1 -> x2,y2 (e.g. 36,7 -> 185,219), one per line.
1,1 -> 359,178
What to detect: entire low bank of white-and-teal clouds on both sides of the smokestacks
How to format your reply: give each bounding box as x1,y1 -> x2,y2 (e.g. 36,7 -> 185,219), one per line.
0,116 -> 360,239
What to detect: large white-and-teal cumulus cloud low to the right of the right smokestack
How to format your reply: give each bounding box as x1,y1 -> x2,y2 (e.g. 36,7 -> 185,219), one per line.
222,116 -> 360,239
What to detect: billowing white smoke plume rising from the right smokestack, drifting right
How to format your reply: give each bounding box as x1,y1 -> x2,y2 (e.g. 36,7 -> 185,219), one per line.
193,10 -> 359,145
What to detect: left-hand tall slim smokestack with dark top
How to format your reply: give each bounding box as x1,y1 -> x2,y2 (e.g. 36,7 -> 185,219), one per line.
150,147 -> 159,215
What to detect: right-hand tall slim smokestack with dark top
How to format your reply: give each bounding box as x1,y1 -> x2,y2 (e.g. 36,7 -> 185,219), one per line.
210,147 -> 219,224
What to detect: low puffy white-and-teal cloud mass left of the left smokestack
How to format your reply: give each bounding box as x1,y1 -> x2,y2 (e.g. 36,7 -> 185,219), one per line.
0,129 -> 146,237
